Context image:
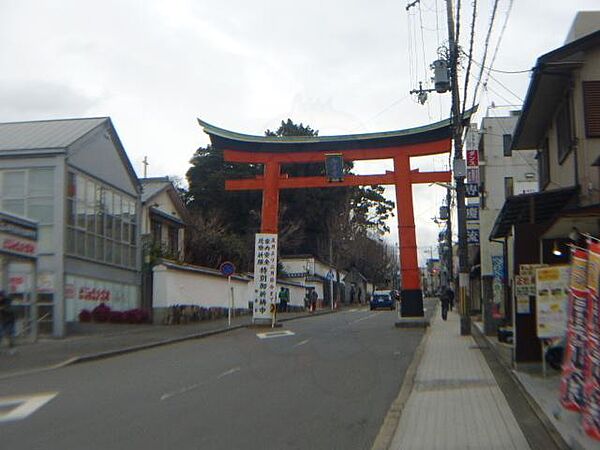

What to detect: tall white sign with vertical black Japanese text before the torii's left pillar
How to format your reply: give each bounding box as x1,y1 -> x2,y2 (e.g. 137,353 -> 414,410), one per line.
252,233 -> 277,320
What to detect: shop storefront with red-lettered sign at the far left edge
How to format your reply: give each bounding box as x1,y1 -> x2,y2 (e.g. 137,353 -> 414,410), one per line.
0,212 -> 38,339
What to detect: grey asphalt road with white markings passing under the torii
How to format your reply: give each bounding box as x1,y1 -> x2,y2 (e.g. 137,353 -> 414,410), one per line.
0,309 -> 423,450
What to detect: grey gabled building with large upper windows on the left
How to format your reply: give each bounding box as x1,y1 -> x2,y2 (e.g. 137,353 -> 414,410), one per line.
0,117 -> 141,337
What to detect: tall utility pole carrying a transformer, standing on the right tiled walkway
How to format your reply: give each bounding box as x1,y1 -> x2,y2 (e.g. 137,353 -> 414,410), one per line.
446,0 -> 471,336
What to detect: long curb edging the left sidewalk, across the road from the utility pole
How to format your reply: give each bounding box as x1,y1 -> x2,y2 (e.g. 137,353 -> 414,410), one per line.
0,309 -> 342,381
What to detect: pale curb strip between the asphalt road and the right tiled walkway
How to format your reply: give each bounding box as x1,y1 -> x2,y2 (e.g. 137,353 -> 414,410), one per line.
371,307 -> 436,450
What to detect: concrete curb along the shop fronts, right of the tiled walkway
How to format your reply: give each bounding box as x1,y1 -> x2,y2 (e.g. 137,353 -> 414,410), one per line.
471,326 -> 571,450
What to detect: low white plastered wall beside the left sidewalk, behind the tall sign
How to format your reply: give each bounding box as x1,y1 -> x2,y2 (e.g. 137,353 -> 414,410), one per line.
153,264 -> 305,308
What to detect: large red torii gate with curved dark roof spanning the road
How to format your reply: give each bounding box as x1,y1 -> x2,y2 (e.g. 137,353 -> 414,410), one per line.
198,116 -> 460,317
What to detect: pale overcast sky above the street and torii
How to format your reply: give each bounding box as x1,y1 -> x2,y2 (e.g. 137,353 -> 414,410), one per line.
0,0 -> 599,259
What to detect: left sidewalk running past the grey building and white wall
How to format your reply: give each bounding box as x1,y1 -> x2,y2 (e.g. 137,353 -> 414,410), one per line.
0,309 -> 332,379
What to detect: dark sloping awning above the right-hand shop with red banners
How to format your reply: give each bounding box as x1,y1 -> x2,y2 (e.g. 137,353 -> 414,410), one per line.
490,187 -> 578,239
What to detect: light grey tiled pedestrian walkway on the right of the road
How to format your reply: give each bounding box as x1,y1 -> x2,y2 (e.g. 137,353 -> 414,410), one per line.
390,313 -> 530,450
